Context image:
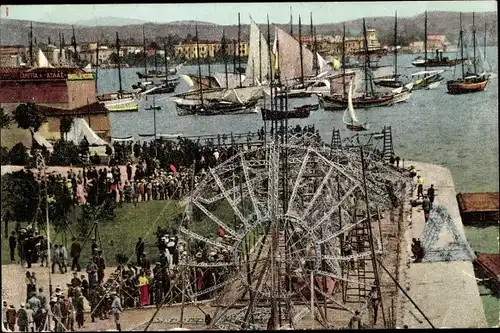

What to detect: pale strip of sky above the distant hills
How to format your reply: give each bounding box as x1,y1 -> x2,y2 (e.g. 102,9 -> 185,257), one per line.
0,1 -> 497,25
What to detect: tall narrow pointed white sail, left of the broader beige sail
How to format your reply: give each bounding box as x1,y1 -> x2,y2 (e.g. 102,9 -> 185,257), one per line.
245,17 -> 269,84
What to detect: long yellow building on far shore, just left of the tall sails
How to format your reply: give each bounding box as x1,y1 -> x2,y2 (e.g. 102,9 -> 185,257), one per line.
175,39 -> 248,60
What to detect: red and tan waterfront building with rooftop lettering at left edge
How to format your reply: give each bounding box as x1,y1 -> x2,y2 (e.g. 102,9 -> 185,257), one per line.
0,67 -> 111,144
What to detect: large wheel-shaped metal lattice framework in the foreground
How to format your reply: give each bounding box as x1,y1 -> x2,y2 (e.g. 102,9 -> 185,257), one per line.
174,138 -> 407,329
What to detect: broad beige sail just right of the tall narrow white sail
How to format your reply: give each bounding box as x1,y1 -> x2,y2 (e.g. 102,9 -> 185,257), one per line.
275,27 -> 316,81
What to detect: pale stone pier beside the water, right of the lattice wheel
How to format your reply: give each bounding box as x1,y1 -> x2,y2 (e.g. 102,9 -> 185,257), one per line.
398,161 -> 488,328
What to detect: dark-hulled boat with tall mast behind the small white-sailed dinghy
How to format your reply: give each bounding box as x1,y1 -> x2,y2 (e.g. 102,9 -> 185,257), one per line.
319,19 -> 411,110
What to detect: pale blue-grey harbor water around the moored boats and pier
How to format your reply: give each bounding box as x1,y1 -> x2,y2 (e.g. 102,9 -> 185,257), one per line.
102,47 -> 499,326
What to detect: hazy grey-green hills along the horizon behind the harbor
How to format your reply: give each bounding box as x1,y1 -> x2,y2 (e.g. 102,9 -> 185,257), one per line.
0,12 -> 498,45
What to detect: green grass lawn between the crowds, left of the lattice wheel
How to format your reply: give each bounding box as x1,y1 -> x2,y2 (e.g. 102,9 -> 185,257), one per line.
1,200 -> 184,266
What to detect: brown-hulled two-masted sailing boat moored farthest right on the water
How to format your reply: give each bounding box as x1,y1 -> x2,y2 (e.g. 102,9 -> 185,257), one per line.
446,13 -> 489,94
